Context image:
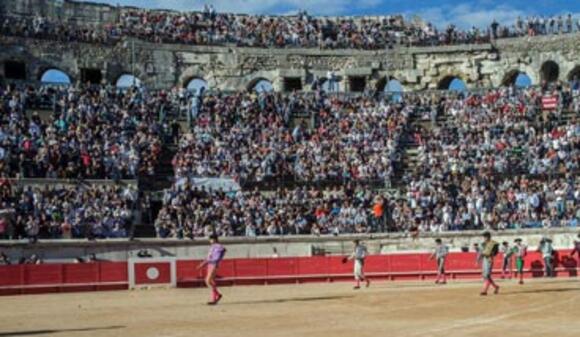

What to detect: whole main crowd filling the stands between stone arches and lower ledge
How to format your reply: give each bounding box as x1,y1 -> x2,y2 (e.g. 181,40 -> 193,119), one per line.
0,71 -> 580,241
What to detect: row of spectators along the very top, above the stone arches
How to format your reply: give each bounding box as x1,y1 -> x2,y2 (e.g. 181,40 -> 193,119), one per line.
0,6 -> 580,50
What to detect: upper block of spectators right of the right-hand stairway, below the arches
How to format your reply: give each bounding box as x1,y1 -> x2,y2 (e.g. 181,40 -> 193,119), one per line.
409,87 -> 580,180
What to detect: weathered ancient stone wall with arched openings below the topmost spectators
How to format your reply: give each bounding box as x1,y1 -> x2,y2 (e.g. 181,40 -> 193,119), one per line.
0,0 -> 580,92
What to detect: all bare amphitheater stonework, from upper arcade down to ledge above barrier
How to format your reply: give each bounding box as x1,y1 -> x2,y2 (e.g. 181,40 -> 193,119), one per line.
0,0 -> 580,259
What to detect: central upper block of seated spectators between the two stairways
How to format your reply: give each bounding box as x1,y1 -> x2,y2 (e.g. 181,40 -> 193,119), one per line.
173,92 -> 412,182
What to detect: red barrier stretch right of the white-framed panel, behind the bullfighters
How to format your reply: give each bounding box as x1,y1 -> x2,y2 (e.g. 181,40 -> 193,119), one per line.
177,250 -> 579,287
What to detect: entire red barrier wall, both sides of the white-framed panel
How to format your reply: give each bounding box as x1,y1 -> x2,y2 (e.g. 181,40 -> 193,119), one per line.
0,250 -> 579,295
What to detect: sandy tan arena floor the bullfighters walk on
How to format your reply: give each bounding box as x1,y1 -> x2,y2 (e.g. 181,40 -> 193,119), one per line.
0,279 -> 580,337
